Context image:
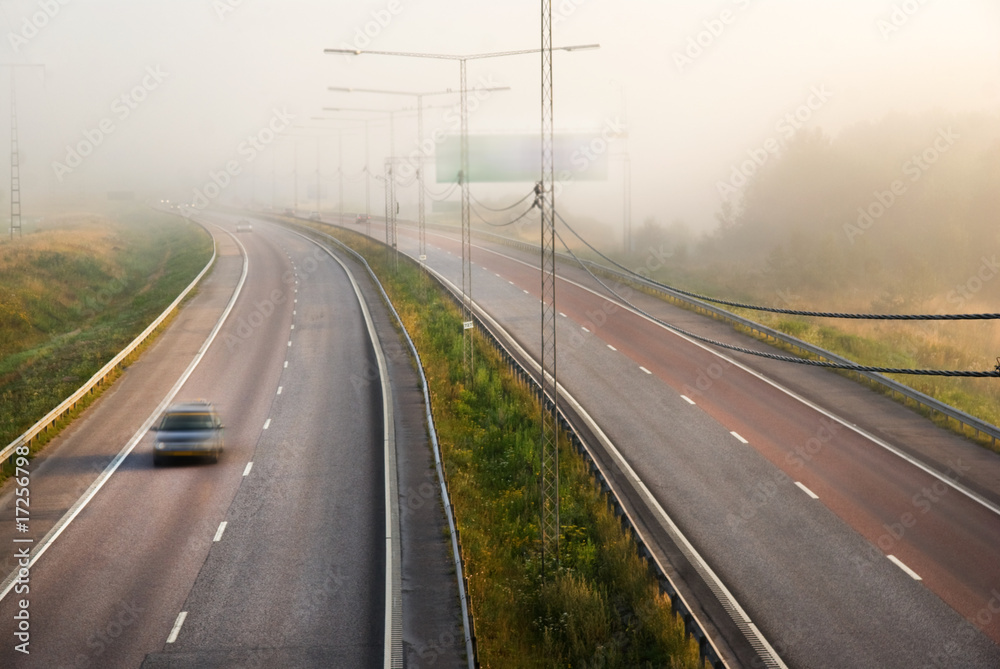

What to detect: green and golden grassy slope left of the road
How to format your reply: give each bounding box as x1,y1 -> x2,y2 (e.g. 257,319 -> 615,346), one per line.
0,208 -> 212,470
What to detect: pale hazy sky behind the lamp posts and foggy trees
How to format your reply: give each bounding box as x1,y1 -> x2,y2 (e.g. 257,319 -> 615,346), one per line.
0,0 -> 1000,235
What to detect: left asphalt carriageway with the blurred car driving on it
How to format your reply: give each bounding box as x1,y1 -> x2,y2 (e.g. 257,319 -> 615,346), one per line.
0,219 -> 385,667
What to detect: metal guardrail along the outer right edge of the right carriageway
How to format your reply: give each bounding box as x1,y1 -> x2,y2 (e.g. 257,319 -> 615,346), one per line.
410,224 -> 1000,447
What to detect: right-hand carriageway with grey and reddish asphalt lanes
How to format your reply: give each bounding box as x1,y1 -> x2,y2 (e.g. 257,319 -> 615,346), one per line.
336,215 -> 1000,668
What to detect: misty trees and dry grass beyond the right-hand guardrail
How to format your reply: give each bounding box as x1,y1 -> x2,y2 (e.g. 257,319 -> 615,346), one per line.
592,113 -> 1000,444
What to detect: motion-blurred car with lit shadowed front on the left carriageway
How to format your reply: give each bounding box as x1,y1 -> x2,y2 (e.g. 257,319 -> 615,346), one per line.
152,400 -> 223,466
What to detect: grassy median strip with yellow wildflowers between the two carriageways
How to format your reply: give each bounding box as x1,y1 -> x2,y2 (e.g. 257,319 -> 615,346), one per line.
306,228 -> 698,667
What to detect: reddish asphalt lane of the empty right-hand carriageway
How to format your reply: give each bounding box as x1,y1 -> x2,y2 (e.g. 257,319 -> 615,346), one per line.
435,227 -> 1000,643
